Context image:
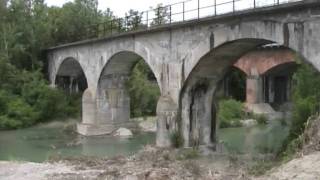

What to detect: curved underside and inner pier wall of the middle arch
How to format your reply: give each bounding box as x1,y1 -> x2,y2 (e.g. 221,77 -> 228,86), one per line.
96,51 -> 160,129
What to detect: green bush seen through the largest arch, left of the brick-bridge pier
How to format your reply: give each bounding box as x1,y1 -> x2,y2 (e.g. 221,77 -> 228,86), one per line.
217,99 -> 245,128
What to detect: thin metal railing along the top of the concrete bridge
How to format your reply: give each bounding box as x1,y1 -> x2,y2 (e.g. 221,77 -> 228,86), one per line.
60,0 -> 303,44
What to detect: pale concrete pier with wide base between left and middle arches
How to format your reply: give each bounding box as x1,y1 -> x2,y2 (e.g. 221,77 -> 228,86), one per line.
77,74 -> 134,136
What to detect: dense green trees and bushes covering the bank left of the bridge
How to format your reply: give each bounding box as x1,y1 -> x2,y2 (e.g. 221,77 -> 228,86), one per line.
0,0 -> 111,129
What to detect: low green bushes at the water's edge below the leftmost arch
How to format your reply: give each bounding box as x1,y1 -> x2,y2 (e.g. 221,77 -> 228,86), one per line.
0,59 -> 81,129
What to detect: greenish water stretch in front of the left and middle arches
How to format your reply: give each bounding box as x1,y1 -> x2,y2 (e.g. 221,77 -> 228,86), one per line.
0,122 -> 155,162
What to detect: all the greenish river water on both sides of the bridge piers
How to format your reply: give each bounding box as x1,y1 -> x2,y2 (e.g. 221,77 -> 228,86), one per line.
0,122 -> 288,162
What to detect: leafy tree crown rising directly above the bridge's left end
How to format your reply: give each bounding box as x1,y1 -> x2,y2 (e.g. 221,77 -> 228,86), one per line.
49,0 -> 105,43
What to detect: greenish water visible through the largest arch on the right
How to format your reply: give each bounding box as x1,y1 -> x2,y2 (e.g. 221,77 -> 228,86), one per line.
218,121 -> 289,154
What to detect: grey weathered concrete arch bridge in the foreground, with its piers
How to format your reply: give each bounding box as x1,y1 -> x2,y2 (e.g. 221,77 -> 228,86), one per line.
48,0 -> 320,146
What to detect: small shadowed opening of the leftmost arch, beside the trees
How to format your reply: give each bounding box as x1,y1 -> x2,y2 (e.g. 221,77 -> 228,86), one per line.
54,57 -> 88,93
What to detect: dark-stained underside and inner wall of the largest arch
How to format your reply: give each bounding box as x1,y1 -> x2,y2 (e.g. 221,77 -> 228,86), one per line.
178,38 -> 316,146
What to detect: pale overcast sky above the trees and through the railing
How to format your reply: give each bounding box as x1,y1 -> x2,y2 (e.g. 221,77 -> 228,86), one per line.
45,0 -> 295,18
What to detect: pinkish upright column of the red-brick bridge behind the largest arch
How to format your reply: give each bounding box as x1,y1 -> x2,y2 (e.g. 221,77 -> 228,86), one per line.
246,75 -> 263,104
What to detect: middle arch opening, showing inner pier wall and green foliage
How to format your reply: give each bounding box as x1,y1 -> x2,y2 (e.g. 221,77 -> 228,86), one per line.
97,51 -> 160,124
